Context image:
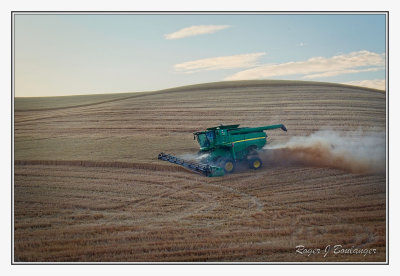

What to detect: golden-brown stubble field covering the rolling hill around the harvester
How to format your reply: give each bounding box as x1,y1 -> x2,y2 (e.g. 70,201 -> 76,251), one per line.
14,81 -> 386,262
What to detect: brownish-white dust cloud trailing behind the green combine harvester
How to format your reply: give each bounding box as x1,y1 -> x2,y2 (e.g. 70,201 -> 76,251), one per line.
260,130 -> 386,174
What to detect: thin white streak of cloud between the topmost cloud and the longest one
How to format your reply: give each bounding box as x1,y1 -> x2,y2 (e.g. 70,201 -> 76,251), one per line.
174,52 -> 266,73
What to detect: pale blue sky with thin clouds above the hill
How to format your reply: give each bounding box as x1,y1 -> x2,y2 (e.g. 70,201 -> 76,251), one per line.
14,14 -> 386,97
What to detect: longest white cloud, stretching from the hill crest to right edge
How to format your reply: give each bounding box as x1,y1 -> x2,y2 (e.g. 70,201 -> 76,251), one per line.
225,50 -> 385,80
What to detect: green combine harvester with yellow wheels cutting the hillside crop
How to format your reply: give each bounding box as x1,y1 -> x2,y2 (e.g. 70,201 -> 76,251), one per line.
158,124 -> 287,177
